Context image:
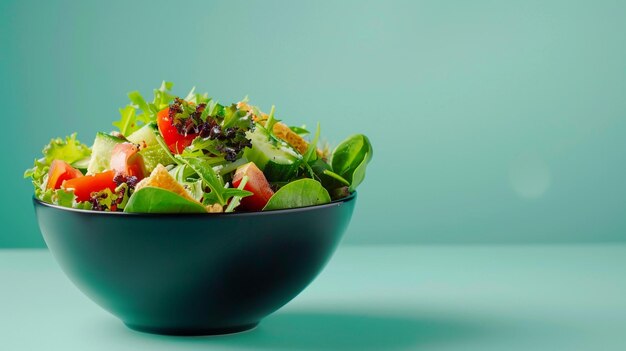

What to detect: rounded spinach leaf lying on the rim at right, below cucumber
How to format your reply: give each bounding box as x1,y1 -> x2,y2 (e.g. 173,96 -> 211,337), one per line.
263,178 -> 330,211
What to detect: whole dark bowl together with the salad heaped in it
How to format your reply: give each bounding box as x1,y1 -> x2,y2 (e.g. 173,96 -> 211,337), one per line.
24,81 -> 373,335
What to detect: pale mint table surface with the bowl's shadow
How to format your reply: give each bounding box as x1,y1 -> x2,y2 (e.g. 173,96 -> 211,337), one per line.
0,245 -> 626,350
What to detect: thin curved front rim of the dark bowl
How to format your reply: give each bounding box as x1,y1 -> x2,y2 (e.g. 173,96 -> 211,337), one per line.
33,191 -> 357,218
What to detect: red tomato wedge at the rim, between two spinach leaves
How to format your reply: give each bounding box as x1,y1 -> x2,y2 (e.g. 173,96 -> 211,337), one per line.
233,162 -> 274,211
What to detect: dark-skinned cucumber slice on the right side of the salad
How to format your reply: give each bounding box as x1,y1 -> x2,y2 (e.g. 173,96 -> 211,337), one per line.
244,128 -> 302,182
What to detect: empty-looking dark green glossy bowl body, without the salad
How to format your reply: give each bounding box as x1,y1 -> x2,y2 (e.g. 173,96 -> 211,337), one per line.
34,194 -> 356,335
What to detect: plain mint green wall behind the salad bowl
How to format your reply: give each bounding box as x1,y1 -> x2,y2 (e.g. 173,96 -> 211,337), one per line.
0,0 -> 626,247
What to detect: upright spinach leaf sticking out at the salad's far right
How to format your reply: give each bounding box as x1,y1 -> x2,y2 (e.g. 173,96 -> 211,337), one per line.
331,134 -> 374,191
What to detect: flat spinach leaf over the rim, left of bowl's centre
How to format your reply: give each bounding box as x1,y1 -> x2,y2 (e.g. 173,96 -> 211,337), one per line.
124,187 -> 207,213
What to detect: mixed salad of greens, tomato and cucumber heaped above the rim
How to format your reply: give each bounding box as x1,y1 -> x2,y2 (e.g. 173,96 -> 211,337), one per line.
24,82 -> 373,213
